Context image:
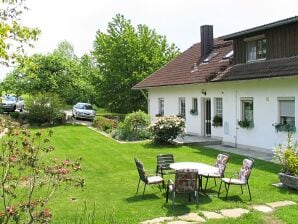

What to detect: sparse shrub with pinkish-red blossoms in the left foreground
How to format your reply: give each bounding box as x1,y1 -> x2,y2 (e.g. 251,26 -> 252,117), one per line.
0,117 -> 84,223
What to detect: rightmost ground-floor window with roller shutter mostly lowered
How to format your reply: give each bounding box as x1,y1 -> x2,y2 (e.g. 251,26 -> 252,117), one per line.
279,99 -> 295,126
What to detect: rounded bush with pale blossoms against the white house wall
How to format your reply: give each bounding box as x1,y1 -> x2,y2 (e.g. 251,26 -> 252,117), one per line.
149,115 -> 185,144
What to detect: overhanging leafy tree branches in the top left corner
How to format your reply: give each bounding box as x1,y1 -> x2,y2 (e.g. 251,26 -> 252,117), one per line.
0,0 -> 40,65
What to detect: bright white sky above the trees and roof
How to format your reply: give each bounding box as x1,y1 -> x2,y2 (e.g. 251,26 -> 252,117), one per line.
0,0 -> 298,78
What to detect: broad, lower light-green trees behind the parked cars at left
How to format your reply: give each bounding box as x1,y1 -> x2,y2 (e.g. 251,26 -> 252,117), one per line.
1,41 -> 100,104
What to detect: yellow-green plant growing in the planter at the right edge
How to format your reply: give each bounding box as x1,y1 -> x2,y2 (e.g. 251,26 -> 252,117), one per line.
274,132 -> 298,176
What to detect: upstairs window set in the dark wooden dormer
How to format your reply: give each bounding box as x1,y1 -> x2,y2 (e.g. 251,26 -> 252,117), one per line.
247,38 -> 267,61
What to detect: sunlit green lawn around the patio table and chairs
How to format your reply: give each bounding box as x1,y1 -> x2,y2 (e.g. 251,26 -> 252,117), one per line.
40,125 -> 298,223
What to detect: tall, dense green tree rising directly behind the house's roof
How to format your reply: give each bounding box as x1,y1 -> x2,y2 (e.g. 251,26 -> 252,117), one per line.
93,14 -> 178,113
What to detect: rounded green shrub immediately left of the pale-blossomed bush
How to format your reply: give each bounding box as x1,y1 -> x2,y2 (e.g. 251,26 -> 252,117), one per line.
112,110 -> 150,141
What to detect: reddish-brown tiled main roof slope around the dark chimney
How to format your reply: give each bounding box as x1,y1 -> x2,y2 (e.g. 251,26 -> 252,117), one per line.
133,39 -> 233,89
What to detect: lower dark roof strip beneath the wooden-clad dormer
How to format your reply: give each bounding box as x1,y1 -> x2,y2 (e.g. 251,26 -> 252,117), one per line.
212,56 -> 298,81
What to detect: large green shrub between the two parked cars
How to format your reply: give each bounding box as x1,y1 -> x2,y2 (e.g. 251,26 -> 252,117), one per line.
26,93 -> 64,125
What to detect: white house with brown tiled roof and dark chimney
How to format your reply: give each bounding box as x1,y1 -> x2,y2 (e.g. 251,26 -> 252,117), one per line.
133,16 -> 298,151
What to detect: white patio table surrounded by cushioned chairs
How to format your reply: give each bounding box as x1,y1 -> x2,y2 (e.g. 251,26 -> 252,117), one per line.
170,162 -> 219,190
